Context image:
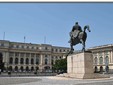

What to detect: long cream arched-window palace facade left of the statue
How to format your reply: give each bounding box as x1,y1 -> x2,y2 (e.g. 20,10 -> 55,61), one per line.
0,40 -> 70,72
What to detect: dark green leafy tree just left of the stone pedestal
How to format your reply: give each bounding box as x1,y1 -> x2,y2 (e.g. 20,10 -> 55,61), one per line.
53,59 -> 67,72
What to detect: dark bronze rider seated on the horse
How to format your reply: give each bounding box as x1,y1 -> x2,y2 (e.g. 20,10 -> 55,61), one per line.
69,22 -> 82,42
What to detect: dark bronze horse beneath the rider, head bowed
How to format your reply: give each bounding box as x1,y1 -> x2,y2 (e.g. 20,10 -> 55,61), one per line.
69,25 -> 91,53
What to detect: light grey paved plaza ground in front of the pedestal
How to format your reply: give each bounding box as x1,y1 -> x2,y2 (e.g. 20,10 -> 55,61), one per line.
0,76 -> 113,85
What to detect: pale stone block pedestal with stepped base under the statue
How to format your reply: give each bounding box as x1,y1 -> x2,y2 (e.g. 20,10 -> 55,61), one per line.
57,52 -> 109,79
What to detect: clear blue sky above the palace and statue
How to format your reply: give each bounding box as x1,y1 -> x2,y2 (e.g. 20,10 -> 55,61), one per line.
0,3 -> 113,49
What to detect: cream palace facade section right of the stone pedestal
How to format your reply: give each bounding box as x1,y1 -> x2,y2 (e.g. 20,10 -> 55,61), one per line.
88,44 -> 113,73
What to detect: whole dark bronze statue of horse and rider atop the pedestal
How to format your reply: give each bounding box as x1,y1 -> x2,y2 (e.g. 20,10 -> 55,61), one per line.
69,22 -> 91,54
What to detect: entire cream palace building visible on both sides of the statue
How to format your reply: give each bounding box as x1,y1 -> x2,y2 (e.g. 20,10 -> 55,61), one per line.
0,40 -> 113,73
